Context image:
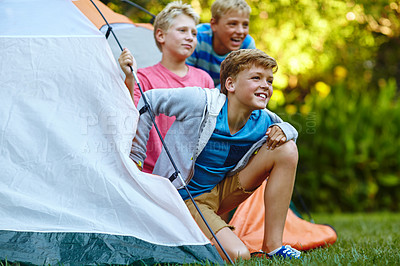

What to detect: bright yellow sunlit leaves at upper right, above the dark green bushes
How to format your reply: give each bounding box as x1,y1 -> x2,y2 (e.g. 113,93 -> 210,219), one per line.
251,0 -> 400,92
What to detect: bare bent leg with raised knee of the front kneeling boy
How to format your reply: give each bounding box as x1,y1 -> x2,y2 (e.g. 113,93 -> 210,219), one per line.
217,141 -> 298,254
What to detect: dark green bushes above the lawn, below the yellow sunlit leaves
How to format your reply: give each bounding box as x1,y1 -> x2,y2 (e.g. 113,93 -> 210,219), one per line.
282,79 -> 400,211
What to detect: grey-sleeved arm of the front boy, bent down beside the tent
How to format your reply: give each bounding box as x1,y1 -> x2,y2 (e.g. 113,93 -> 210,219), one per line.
130,87 -> 207,167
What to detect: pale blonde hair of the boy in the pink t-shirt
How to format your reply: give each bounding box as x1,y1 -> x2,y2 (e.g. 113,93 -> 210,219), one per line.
153,1 -> 200,51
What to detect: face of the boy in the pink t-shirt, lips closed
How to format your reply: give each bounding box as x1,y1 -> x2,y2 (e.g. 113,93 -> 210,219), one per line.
156,14 -> 197,60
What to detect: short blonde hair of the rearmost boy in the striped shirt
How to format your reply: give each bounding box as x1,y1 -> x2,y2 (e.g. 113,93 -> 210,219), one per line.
211,0 -> 251,22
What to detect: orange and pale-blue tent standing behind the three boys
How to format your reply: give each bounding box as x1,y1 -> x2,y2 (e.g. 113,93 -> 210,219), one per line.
74,0 -> 337,255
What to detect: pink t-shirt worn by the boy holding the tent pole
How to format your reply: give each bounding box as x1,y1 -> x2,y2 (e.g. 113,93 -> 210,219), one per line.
134,63 -> 214,173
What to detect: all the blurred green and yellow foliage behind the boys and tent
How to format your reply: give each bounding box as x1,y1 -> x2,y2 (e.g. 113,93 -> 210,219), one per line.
102,0 -> 400,211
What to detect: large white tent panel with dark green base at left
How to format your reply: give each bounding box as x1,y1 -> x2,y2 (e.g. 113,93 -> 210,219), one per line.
0,0 -> 222,265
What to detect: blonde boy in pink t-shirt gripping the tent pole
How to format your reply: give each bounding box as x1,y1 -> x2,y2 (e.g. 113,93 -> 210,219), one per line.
118,1 -> 214,173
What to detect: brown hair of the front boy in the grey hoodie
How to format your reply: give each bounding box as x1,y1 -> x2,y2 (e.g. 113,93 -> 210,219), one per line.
220,49 -> 278,94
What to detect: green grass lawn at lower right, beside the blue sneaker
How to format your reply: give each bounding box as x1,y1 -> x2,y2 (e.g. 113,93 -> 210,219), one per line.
237,213 -> 400,266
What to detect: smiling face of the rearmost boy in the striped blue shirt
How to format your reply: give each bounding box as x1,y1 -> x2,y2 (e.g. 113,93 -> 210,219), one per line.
210,10 -> 249,55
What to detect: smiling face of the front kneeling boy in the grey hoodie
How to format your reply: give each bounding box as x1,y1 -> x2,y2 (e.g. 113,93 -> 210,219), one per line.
226,66 -> 274,111
